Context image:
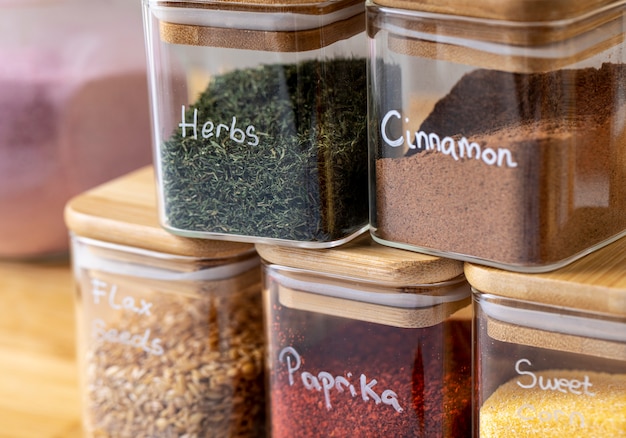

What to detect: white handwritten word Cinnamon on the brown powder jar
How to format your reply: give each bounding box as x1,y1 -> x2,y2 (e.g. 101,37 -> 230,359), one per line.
380,110 -> 518,168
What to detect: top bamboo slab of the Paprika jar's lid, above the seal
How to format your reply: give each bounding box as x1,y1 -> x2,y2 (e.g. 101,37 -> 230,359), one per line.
256,234 -> 463,287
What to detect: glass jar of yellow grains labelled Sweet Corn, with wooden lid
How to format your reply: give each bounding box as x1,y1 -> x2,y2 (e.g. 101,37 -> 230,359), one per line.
465,239 -> 626,438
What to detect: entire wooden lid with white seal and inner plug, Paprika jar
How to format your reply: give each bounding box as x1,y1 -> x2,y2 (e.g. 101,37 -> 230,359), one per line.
256,234 -> 470,328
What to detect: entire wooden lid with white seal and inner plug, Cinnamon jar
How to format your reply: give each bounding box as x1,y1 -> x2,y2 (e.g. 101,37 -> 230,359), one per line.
369,0 -> 625,73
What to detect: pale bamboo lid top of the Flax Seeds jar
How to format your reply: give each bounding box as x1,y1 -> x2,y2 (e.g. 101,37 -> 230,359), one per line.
65,166 -> 254,258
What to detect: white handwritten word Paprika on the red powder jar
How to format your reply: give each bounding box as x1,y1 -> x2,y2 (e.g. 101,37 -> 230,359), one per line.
278,346 -> 404,412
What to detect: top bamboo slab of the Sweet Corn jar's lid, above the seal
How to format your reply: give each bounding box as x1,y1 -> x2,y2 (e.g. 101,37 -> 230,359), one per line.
465,234 -> 626,318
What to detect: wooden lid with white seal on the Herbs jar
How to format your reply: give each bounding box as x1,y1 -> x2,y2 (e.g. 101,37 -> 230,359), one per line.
155,0 -> 365,52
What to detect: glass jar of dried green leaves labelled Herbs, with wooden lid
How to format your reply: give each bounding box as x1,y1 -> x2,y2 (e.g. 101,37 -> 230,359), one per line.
144,0 -> 368,248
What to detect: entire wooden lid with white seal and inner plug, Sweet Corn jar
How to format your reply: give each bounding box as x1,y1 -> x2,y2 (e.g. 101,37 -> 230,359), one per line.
465,238 -> 626,361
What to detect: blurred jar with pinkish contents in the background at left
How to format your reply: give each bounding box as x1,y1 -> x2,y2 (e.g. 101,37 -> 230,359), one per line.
0,0 -> 152,259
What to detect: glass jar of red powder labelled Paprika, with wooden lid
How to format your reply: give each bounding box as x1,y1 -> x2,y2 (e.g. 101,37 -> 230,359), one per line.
256,236 -> 471,438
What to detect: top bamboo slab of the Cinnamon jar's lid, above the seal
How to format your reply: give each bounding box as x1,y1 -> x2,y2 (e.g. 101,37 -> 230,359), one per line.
374,0 -> 620,22
